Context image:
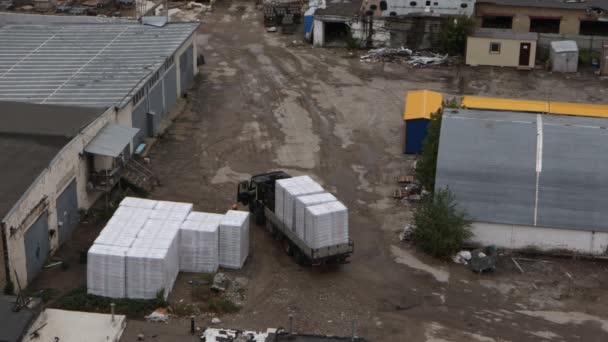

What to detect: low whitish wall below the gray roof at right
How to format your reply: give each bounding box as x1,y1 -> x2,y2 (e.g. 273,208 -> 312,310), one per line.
471,222 -> 608,255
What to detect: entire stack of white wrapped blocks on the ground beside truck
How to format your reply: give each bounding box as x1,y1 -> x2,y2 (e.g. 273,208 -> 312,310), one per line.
87,197 -> 249,299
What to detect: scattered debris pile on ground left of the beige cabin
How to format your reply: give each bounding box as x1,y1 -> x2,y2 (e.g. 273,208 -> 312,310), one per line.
361,47 -> 451,67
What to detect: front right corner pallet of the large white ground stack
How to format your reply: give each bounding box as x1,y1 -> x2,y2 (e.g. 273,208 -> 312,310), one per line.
126,247 -> 177,299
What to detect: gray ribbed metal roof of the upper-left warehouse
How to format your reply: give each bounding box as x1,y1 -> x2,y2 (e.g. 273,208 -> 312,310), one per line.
0,23 -> 199,108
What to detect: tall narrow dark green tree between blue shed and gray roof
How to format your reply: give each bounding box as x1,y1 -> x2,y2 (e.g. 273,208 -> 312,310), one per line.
416,110 -> 442,192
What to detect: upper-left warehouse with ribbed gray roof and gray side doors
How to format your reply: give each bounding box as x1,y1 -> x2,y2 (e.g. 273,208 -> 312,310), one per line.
0,23 -> 199,143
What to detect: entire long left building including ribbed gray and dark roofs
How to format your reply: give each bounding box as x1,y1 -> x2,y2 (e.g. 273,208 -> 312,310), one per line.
0,23 -> 199,287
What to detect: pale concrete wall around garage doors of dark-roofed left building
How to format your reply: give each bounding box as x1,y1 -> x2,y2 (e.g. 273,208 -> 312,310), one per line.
2,108 -> 116,286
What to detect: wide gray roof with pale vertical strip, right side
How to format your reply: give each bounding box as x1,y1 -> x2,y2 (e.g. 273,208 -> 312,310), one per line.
436,110 -> 608,231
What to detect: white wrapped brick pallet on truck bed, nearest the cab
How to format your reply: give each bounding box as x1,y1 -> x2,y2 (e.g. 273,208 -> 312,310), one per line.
275,176 -> 324,230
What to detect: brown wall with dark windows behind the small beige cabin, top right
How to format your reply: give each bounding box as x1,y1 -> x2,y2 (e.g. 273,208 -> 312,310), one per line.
475,3 -> 592,34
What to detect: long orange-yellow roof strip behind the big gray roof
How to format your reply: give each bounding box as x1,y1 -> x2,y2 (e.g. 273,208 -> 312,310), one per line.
462,96 -> 608,118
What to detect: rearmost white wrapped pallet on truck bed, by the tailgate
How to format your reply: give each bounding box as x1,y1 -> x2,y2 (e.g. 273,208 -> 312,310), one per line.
304,201 -> 348,248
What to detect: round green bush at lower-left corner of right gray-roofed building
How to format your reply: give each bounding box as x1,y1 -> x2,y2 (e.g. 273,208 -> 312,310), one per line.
412,188 -> 472,258
